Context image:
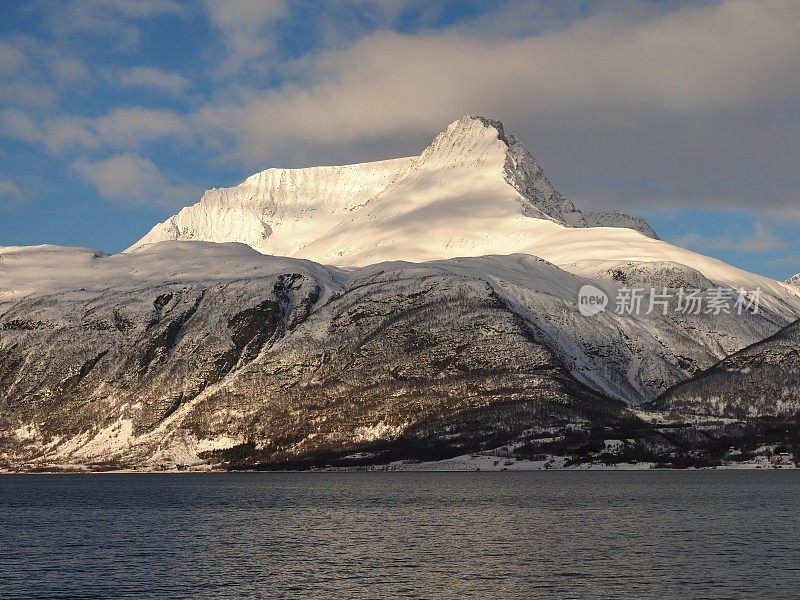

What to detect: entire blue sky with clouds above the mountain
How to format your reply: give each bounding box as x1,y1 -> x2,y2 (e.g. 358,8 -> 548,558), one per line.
0,0 -> 800,278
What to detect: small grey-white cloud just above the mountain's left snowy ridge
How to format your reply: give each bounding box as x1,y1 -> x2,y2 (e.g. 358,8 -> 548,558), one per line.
72,153 -> 200,206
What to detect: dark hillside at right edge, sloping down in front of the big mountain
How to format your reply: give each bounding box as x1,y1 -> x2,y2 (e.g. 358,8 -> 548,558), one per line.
653,321 -> 800,418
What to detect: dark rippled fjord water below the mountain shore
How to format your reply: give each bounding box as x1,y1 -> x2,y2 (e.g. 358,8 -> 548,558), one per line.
0,471 -> 800,598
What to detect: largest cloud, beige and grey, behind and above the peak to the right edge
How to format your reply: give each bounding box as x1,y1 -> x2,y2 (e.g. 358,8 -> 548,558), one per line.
197,0 -> 800,216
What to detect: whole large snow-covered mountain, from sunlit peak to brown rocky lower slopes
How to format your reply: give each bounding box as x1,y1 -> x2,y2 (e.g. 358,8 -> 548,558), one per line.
0,117 -> 800,468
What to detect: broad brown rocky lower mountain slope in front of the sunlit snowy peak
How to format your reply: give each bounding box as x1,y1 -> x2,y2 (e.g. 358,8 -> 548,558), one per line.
0,242 -> 796,468
